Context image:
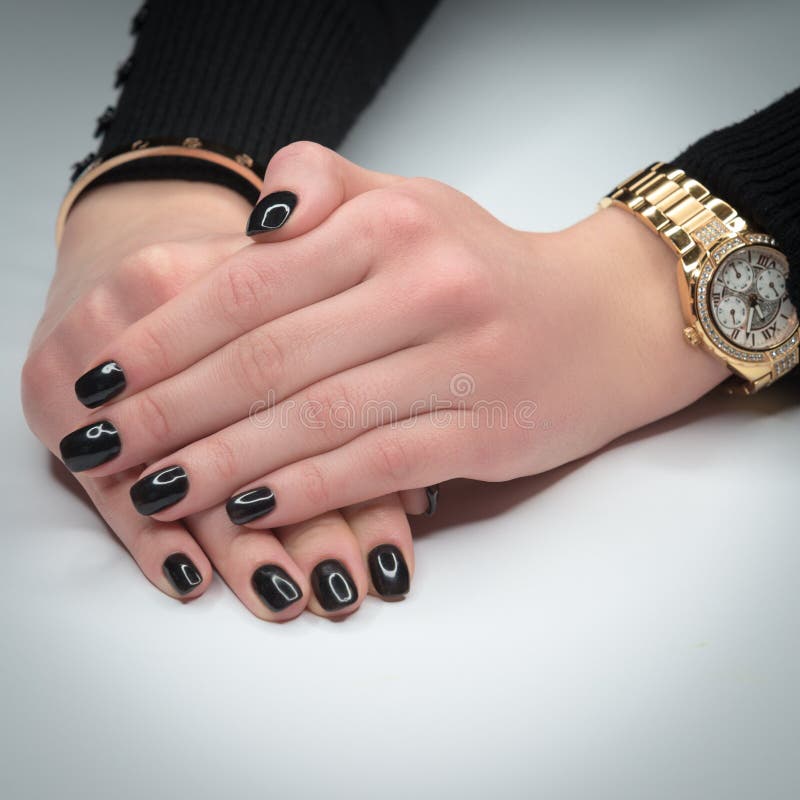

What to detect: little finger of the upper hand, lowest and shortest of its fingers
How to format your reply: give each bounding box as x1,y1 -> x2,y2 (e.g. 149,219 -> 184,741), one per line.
234,414 -> 462,528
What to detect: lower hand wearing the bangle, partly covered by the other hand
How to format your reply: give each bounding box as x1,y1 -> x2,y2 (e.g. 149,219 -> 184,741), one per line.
23,181 -> 419,620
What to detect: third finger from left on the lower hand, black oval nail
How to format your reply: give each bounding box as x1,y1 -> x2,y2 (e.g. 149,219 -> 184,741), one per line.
278,511 -> 369,617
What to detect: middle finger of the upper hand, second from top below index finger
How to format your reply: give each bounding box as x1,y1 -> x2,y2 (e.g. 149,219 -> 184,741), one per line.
70,277 -> 440,475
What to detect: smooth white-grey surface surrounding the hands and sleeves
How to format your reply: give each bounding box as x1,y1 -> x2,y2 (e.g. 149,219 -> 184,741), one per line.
0,0 -> 800,800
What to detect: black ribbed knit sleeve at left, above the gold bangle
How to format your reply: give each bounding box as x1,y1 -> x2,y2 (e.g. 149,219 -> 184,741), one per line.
76,0 -> 436,200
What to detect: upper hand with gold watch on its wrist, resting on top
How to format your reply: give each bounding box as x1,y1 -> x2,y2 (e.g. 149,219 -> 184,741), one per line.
59,143 -> 727,527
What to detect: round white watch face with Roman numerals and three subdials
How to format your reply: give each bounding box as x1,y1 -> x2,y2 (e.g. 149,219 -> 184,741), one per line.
708,245 -> 797,350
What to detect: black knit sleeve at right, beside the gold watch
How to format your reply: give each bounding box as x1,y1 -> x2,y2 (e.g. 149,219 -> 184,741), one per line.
672,89 -> 800,308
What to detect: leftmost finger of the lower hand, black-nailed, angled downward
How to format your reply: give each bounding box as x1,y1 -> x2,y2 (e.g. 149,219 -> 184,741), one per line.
83,474 -> 209,600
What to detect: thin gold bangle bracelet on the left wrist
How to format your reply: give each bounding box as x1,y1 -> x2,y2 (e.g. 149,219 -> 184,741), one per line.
56,136 -> 263,247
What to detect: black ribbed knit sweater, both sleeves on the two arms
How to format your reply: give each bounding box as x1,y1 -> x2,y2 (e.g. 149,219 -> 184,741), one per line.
81,0 -> 800,332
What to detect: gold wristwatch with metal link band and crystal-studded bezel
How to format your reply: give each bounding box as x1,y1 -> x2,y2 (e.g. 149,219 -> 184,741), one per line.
600,162 -> 800,394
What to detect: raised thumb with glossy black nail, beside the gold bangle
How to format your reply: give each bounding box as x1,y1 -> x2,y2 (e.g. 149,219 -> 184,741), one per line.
247,142 -> 402,242
